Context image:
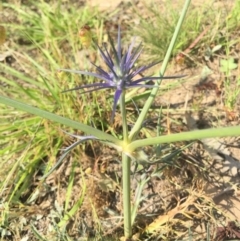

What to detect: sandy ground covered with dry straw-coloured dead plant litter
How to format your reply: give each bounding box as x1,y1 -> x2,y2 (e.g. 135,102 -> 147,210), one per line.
0,0 -> 240,241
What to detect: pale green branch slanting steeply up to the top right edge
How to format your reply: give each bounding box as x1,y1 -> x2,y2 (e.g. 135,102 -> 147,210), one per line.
129,0 -> 191,141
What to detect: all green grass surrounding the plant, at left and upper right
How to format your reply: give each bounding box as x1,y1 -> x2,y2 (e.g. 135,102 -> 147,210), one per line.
0,1 -> 240,241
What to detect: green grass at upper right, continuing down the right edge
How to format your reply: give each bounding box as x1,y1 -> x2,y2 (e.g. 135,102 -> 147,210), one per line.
134,1 -> 240,111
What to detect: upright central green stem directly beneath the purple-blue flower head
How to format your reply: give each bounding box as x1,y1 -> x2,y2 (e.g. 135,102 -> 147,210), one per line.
120,91 -> 132,238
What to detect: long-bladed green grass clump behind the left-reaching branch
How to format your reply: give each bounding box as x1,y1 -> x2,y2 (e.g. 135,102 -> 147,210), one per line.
0,1 -> 111,240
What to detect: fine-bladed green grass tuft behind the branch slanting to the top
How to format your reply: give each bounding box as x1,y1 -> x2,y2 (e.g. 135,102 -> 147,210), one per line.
131,1 -> 216,63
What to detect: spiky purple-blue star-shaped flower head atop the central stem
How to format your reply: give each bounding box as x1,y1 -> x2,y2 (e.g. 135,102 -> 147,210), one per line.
60,27 -> 182,121
